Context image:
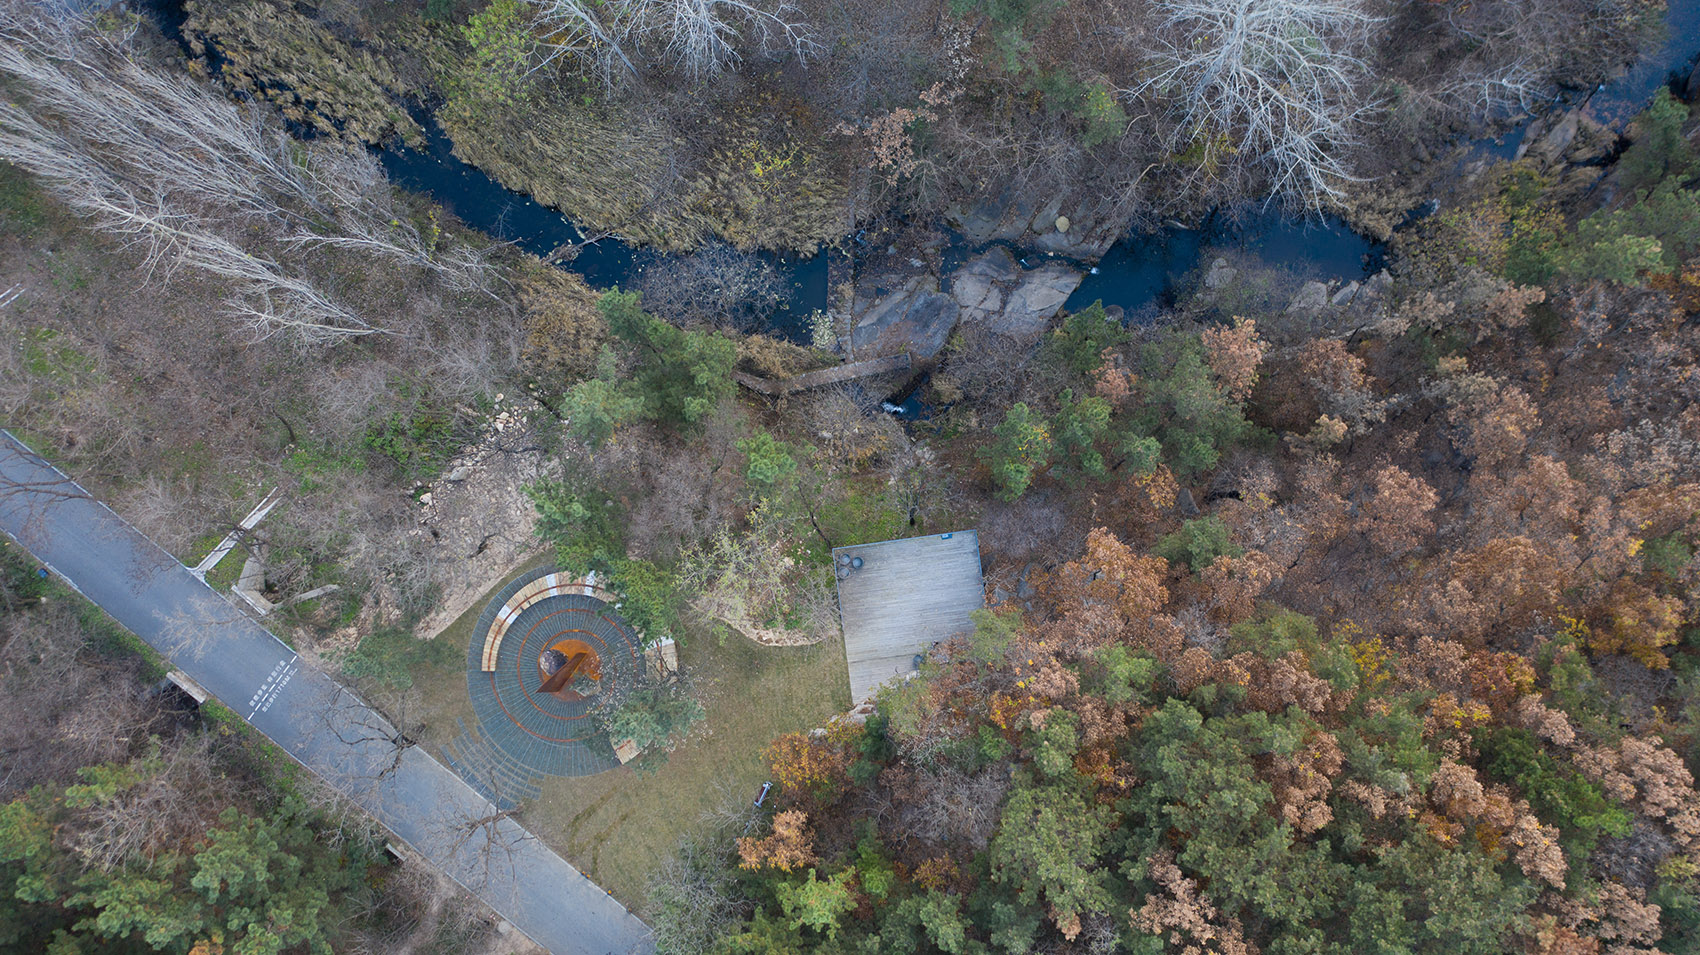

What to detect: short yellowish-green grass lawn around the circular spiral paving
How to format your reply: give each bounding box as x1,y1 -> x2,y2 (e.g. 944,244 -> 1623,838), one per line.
399,552 -> 850,914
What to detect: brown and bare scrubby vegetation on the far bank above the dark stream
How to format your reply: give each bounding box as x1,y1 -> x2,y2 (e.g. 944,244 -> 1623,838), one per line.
184,0 -> 1663,244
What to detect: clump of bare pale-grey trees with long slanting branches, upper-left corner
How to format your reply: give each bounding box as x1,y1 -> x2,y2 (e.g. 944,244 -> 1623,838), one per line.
0,2 -> 485,342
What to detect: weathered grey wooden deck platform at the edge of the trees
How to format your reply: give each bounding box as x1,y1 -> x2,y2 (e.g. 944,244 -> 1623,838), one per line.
833,530 -> 986,704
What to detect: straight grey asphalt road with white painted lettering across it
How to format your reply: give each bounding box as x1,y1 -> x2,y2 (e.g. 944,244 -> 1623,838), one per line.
0,432 -> 655,955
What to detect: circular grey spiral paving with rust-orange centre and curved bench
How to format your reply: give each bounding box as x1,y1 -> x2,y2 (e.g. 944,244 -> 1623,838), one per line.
449,568 -> 641,805
